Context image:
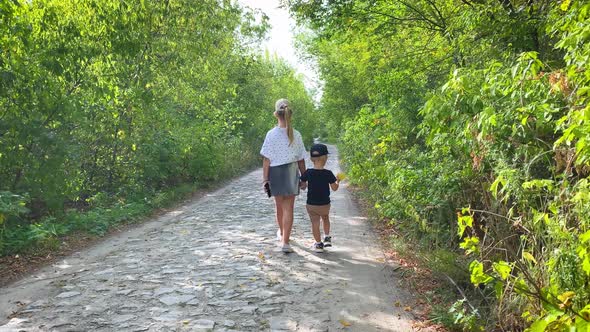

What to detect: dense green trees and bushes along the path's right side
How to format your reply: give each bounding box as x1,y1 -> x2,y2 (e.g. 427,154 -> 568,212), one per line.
285,0 -> 590,331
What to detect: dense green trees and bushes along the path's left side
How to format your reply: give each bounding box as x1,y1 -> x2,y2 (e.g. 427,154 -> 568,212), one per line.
0,0 -> 313,255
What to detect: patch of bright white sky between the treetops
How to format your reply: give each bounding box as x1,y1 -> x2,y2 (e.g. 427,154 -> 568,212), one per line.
238,0 -> 320,98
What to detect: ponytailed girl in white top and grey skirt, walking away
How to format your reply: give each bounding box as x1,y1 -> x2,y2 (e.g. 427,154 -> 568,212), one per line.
260,99 -> 305,253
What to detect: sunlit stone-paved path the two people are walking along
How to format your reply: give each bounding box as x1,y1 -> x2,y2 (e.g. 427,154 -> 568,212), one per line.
0,147 -> 426,331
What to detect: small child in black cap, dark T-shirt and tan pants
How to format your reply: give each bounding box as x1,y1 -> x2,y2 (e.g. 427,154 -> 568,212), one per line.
301,144 -> 340,252
